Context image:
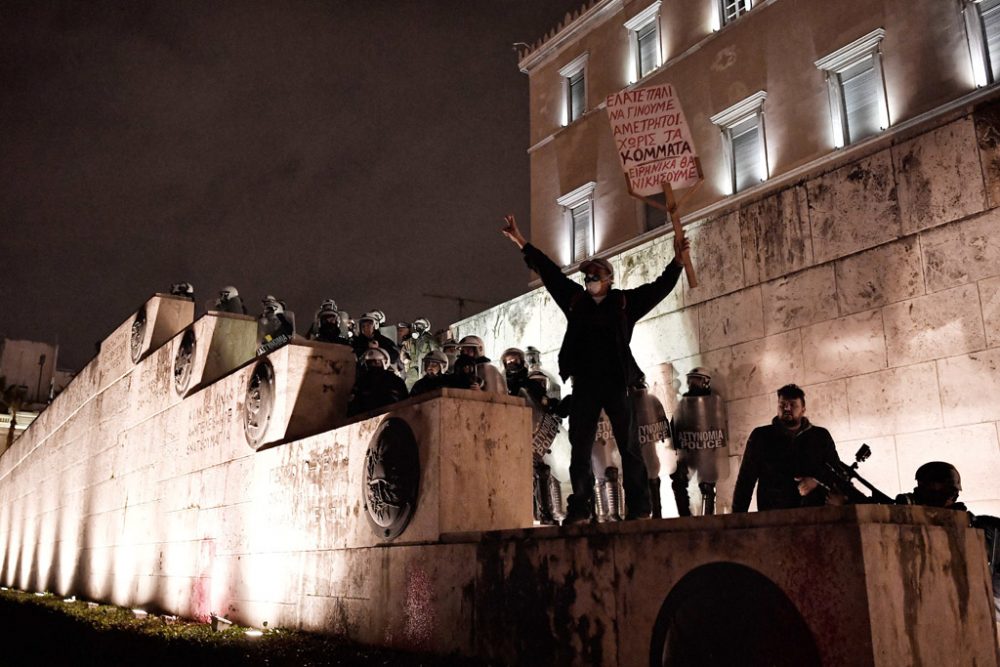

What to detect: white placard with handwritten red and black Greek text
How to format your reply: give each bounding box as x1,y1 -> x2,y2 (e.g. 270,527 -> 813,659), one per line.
607,84 -> 698,196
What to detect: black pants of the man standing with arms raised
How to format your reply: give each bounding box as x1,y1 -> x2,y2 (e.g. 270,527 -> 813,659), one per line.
569,378 -> 650,516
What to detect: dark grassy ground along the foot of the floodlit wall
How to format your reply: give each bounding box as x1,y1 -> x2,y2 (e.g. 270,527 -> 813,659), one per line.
0,591 -> 486,667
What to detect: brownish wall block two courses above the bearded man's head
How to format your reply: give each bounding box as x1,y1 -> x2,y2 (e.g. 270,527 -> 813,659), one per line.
760,264 -> 838,335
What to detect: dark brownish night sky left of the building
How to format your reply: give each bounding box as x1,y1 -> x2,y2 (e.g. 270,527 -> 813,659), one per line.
0,0 -> 582,369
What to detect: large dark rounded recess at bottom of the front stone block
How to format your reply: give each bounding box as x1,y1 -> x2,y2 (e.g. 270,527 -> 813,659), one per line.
649,563 -> 820,667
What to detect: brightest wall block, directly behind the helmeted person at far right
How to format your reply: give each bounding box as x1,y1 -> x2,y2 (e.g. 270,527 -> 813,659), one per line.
896,423 -> 1000,502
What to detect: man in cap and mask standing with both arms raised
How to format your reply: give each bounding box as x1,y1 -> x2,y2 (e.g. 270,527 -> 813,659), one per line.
502,215 -> 689,523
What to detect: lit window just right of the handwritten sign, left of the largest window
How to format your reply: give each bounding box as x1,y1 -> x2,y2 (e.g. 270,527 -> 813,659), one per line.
711,90 -> 767,192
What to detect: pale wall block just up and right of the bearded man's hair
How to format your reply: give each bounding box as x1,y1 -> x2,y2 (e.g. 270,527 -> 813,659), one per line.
802,310 -> 886,384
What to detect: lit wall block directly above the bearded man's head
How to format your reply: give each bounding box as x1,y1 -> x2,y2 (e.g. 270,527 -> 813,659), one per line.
728,329 -> 802,398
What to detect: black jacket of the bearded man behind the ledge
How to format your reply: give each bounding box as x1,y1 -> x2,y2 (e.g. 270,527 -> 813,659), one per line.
733,417 -> 840,512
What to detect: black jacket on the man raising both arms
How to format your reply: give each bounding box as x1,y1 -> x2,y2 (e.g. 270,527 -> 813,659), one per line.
523,243 -> 683,386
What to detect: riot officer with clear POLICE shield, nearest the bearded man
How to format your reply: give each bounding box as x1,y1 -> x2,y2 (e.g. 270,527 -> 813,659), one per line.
670,367 -> 729,516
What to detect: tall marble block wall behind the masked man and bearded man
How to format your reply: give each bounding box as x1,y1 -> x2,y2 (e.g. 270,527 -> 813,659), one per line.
454,105 -> 1000,514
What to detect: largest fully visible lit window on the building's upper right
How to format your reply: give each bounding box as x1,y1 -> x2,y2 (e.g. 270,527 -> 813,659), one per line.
816,28 -> 889,148
